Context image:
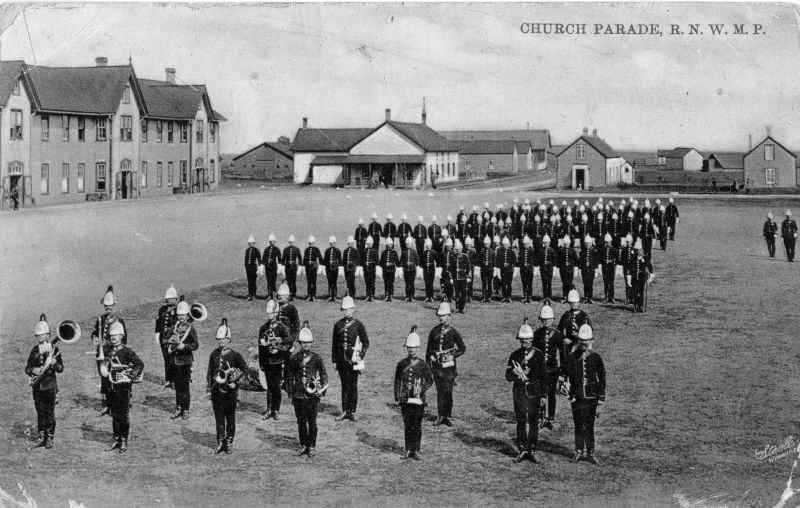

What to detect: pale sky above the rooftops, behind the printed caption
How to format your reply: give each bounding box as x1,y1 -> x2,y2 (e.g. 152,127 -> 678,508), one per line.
0,3 -> 800,153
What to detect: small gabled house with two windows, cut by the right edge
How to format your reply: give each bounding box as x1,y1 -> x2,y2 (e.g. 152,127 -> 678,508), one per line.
744,135 -> 798,188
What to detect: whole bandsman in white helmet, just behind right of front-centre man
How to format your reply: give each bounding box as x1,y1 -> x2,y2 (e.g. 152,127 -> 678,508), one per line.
425,302 -> 467,427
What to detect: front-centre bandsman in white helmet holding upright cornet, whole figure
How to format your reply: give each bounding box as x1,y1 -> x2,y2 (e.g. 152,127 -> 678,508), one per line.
394,326 -> 433,460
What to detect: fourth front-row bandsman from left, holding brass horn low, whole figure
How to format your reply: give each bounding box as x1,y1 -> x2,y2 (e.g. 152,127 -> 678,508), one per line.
287,327 -> 328,458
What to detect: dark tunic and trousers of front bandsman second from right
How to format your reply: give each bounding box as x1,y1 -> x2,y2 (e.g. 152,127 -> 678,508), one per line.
506,348 -> 547,452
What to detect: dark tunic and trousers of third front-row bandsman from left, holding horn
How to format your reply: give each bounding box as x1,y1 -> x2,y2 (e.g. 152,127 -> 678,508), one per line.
206,347 -> 247,443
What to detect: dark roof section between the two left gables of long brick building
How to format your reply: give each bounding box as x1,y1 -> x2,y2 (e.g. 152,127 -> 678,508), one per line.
26,65 -> 144,114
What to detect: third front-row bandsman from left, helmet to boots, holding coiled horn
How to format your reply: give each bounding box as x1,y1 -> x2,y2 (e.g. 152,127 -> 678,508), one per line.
206,320 -> 247,454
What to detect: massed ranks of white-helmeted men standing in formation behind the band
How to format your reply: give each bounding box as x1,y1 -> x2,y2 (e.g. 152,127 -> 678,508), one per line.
239,197 -> 680,313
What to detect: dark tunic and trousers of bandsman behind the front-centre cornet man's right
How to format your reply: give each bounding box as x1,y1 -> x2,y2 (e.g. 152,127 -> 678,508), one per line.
425,323 -> 467,418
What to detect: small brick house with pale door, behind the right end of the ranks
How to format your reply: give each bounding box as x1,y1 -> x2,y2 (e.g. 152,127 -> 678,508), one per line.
556,128 -> 625,190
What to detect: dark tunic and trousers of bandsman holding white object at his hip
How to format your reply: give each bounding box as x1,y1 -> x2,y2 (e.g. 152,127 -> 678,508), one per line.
331,317 -> 369,414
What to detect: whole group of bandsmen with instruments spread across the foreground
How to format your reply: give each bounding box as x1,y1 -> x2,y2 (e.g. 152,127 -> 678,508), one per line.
25,285 -> 606,465
